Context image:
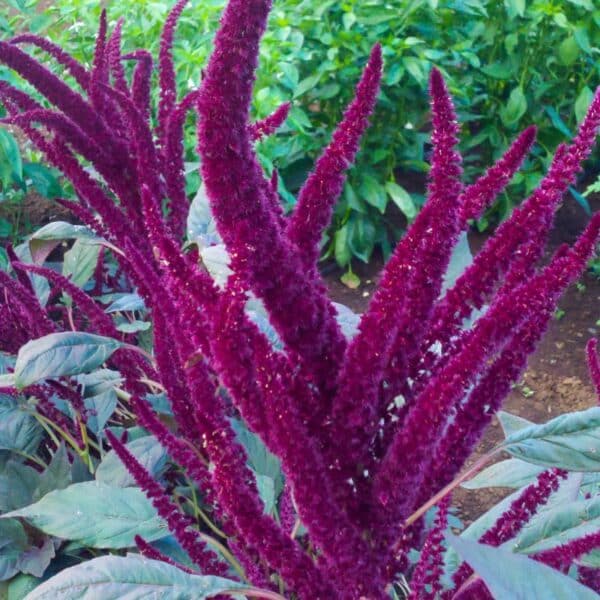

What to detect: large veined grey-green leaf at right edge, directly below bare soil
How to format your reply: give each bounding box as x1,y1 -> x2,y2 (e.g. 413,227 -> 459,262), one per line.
502,407 -> 600,471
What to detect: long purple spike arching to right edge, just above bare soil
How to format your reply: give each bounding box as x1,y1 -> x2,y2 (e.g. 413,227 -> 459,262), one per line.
373,213 -> 600,539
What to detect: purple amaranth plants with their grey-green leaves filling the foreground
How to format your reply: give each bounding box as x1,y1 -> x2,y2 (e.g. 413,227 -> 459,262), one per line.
0,0 -> 600,600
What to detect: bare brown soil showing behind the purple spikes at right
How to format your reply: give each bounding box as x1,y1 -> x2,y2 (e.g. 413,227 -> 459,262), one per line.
327,197 -> 600,524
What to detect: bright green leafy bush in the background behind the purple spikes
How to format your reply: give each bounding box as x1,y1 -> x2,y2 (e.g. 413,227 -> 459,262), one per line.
6,0 -> 600,265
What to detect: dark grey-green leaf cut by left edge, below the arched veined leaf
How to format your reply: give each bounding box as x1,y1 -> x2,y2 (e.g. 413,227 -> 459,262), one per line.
0,394 -> 43,454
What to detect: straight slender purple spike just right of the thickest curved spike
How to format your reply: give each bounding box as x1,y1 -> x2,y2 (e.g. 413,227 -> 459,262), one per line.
287,44 -> 383,271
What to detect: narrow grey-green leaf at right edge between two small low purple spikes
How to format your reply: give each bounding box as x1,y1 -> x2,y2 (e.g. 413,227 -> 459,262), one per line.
511,496 -> 600,554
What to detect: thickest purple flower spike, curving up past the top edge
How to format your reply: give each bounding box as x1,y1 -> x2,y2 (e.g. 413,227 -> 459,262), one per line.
198,0 -> 345,396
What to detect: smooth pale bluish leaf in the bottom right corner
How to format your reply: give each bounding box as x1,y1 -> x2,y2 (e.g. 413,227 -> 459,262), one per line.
447,535 -> 598,600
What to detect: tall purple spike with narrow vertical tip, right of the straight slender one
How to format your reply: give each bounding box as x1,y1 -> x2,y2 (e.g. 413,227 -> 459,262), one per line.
331,69 -> 461,492
